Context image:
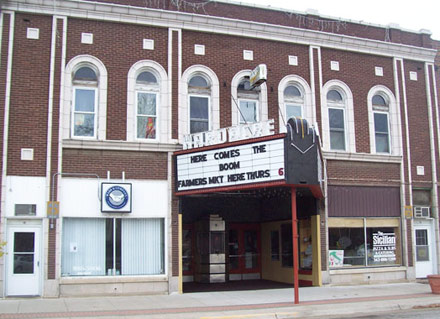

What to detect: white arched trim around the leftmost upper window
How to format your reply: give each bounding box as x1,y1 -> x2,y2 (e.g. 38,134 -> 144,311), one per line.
62,55 -> 107,141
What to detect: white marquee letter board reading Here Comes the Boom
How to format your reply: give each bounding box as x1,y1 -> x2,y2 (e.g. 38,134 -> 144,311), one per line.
177,138 -> 284,191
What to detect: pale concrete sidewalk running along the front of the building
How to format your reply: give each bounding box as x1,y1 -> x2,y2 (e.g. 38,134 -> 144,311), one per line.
0,283 -> 440,319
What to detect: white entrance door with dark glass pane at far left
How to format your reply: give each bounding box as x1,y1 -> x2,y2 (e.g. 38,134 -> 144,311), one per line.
6,226 -> 41,296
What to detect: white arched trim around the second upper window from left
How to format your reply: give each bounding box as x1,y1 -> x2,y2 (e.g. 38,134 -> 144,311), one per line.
127,60 -> 171,143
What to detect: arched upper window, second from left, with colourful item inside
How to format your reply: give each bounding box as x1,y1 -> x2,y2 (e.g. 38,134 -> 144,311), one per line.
135,71 -> 159,139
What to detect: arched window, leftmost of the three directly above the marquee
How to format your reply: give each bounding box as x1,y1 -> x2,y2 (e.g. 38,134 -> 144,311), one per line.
188,74 -> 211,134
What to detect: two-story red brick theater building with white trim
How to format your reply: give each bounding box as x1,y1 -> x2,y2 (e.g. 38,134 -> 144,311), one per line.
0,0 -> 440,296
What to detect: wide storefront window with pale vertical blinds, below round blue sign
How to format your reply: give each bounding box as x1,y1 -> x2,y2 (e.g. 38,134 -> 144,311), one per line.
61,218 -> 165,276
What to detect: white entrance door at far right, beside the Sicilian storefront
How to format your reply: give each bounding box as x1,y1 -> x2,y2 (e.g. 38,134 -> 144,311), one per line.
414,222 -> 435,278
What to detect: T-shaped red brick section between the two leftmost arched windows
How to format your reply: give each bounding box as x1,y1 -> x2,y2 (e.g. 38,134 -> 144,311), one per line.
67,19 -> 168,140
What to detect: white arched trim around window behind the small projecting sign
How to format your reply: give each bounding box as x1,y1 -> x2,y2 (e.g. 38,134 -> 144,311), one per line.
231,70 -> 268,126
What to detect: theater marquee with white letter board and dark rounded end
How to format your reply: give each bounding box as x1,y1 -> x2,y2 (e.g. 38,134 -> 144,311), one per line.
174,119 -> 323,198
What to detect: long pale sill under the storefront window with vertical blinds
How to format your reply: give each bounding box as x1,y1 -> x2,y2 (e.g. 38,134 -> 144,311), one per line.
60,275 -> 168,285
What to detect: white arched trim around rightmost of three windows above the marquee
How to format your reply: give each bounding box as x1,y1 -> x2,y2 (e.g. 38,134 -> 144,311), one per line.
278,75 -> 316,133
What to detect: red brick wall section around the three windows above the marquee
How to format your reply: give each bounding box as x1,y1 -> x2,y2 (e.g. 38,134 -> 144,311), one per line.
182,31 -> 310,127
